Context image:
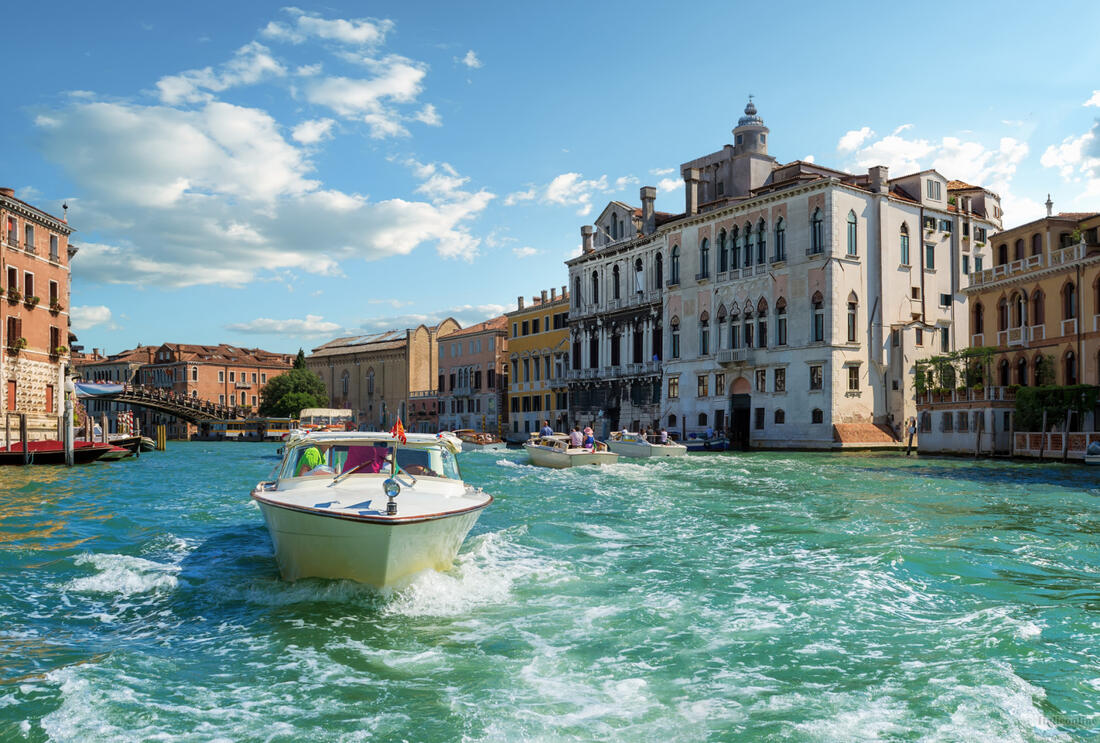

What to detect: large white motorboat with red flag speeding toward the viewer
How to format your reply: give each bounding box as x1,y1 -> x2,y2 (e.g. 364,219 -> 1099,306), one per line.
252,431 -> 493,588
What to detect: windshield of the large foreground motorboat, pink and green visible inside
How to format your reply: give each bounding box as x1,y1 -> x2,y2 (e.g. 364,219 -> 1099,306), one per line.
279,441 -> 462,480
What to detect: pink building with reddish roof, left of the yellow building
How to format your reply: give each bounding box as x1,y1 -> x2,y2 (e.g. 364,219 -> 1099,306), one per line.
439,316 -> 508,433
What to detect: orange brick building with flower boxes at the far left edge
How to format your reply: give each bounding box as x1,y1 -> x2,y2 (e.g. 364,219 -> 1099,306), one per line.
0,188 -> 76,444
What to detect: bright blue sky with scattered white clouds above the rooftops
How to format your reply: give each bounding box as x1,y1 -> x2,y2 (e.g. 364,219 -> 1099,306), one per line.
0,0 -> 1100,353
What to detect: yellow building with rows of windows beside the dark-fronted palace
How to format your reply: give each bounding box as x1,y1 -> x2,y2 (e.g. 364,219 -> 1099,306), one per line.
505,286 -> 569,439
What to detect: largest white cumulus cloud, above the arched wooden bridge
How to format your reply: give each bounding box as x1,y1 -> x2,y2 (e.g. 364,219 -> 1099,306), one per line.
37,101 -> 493,286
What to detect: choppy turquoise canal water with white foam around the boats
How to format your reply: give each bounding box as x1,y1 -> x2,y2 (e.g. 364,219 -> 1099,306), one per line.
0,444 -> 1100,743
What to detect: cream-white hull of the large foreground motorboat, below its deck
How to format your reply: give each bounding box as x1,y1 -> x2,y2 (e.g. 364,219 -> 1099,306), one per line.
257,499 -> 488,588
